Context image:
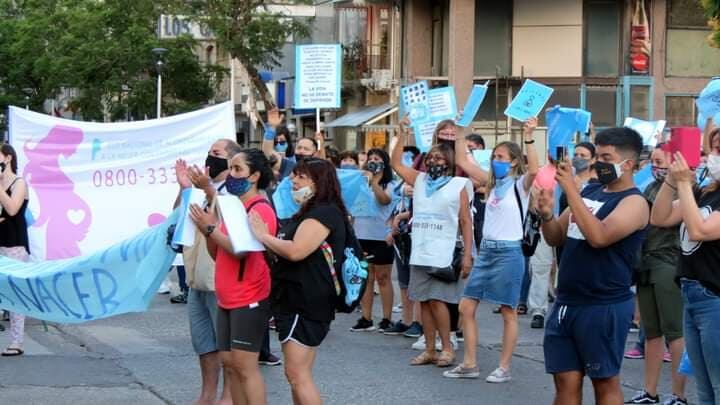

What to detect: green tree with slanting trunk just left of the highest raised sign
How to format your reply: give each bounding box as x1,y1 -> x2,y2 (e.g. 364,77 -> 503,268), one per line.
178,0 -> 313,109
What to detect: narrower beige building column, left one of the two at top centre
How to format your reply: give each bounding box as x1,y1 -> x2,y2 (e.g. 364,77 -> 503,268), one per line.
402,0 -> 432,80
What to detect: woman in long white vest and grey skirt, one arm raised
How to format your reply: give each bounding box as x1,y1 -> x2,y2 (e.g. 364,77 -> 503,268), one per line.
391,118 -> 473,367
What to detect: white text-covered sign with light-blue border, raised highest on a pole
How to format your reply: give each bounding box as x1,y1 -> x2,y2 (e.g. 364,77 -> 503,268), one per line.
295,44 -> 342,109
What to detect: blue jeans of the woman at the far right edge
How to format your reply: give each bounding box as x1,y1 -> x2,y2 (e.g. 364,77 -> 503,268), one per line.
682,279 -> 720,404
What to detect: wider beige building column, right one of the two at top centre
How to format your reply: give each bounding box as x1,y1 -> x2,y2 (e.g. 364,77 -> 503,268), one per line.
448,0 -> 475,108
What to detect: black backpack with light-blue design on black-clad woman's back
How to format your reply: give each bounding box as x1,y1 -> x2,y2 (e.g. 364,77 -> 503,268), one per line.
320,215 -> 368,314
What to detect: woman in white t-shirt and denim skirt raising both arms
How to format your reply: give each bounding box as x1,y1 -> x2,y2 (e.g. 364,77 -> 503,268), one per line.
443,118 -> 538,383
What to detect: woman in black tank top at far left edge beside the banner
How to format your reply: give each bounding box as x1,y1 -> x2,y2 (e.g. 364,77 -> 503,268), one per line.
0,144 -> 30,356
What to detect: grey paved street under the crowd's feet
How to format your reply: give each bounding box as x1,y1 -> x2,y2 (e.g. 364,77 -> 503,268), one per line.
0,280 -> 695,405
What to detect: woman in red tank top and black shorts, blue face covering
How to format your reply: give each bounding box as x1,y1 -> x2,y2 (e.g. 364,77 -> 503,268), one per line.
190,149 -> 277,404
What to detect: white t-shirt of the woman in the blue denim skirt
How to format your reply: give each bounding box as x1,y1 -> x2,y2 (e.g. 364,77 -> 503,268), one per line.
483,175 -> 530,241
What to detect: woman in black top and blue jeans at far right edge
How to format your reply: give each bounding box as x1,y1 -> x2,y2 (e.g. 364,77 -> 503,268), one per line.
650,128 -> 720,404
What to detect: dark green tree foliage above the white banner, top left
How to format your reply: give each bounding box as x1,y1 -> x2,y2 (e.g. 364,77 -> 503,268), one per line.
0,0 -> 226,120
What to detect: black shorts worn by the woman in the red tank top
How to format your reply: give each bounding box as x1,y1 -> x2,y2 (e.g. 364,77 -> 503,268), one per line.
217,300 -> 270,353
